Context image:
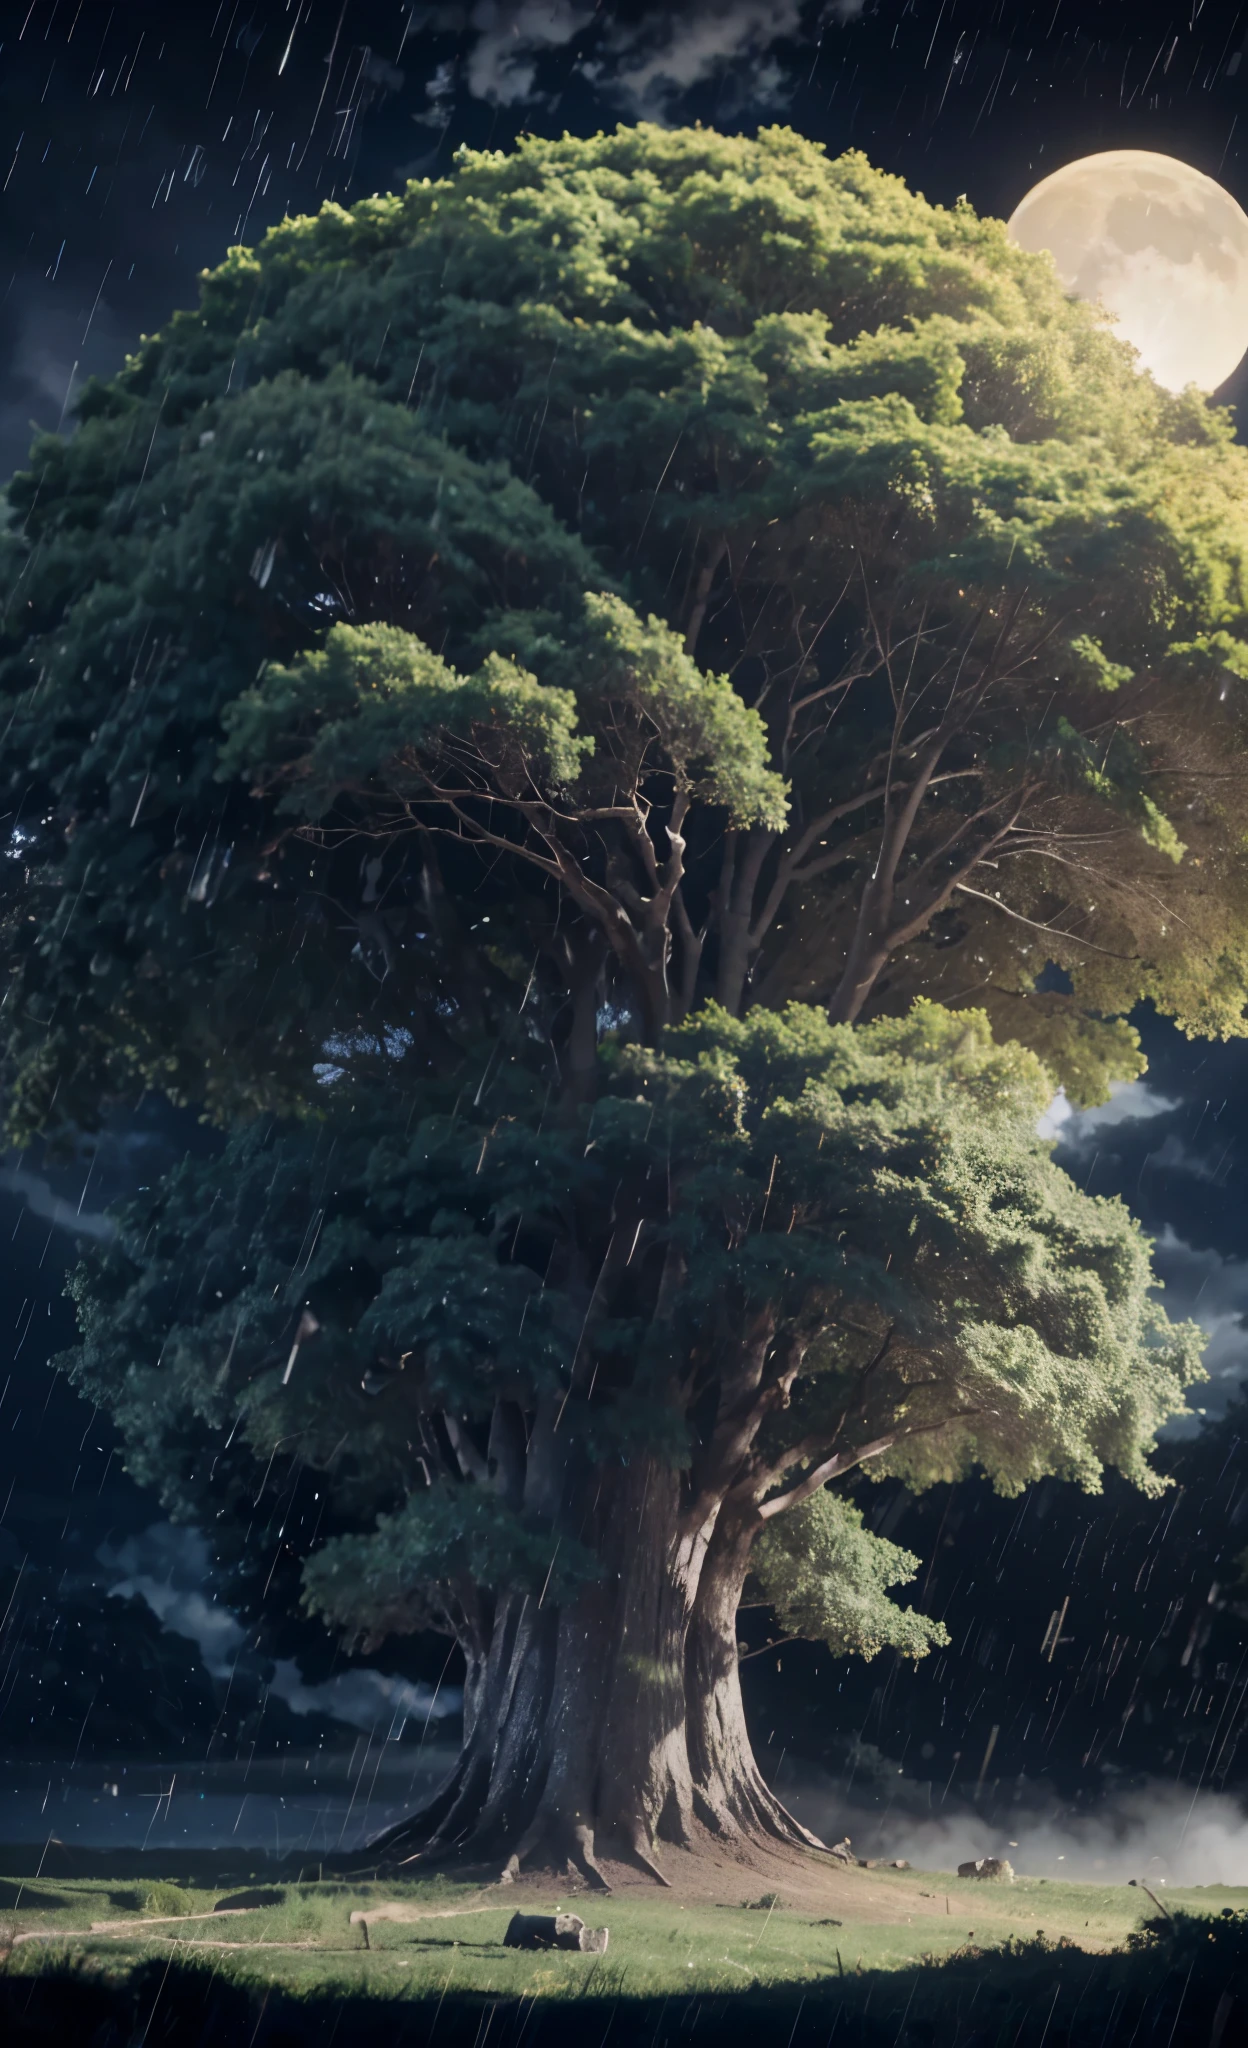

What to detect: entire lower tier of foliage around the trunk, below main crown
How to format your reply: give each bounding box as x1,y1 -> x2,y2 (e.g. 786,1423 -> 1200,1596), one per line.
61,1004 -> 1201,1655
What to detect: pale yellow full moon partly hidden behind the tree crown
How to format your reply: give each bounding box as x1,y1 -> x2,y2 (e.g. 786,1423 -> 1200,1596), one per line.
1008,150 -> 1248,391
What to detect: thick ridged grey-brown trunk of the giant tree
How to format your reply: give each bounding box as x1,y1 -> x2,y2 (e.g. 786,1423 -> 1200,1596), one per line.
352,1460 -> 818,1886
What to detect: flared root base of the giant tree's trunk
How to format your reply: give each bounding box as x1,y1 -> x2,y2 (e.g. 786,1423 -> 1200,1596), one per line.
336,1531 -> 828,1892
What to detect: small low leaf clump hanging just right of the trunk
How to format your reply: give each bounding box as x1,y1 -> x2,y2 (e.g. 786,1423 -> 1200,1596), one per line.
752,1493 -> 949,1657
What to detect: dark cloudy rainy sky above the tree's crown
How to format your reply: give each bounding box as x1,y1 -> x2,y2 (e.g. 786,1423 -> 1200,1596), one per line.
0,0 -> 1240,473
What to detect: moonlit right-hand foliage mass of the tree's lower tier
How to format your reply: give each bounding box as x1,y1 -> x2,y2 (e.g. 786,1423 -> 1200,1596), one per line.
621,1004 -> 1203,1493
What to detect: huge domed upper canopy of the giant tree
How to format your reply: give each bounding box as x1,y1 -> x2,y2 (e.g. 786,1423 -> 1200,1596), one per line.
0,127 -> 1248,1155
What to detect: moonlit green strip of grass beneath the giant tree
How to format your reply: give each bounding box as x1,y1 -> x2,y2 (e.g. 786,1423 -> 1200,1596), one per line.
0,1870 -> 1213,1997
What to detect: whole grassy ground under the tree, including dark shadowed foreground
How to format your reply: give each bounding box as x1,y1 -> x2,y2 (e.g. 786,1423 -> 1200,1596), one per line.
0,1858 -> 1248,2048
